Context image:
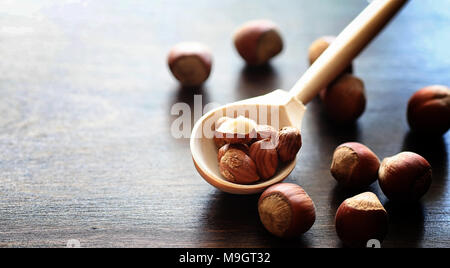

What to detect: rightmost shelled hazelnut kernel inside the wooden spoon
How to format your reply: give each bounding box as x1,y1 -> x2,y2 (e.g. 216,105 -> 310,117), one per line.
277,127 -> 302,162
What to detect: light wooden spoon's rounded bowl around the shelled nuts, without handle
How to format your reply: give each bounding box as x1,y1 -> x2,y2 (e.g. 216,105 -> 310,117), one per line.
190,90 -> 305,194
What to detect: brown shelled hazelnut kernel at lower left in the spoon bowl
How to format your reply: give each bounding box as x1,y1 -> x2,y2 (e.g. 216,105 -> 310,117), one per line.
219,149 -> 259,184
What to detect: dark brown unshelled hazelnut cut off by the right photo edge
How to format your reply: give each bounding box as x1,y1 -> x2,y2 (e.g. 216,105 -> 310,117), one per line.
407,85 -> 450,135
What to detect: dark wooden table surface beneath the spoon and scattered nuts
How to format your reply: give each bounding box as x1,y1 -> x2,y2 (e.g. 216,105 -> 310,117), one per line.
0,0 -> 450,247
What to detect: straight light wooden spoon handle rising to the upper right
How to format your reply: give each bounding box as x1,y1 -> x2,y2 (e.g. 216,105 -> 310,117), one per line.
290,0 -> 408,104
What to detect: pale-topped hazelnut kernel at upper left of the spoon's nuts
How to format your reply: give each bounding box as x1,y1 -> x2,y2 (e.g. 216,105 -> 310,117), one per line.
214,116 -> 257,144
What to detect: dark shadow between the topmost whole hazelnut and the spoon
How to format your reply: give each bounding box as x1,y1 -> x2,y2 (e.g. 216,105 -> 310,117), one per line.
236,63 -> 280,100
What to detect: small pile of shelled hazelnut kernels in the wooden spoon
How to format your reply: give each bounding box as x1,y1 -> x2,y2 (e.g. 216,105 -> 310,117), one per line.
214,116 -> 302,184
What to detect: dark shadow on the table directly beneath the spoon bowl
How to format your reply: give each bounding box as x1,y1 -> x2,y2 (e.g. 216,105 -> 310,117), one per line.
199,191 -> 310,247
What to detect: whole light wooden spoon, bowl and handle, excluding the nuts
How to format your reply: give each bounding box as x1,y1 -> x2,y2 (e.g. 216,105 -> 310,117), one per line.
190,0 -> 407,194
